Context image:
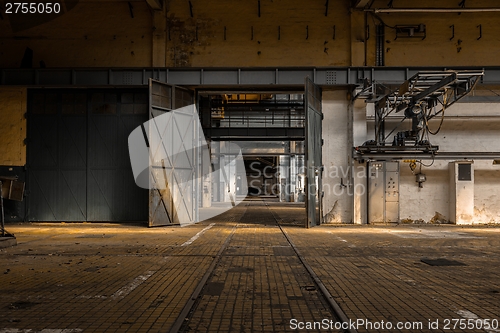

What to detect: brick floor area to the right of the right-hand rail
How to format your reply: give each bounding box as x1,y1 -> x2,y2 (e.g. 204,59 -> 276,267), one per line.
273,206 -> 500,332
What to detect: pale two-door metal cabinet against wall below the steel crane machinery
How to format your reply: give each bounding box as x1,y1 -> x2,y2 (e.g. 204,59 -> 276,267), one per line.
368,162 -> 399,223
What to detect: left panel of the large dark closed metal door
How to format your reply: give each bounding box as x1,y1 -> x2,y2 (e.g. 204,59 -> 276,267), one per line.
26,91 -> 87,221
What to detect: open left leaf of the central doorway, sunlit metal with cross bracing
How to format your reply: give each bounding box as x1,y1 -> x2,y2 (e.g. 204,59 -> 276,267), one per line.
145,79 -> 200,227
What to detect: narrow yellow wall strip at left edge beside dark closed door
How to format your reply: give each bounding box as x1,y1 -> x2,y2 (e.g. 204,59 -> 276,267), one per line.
0,88 -> 26,166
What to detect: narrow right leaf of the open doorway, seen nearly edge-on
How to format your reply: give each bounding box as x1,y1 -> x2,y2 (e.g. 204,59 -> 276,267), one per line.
305,78 -> 323,228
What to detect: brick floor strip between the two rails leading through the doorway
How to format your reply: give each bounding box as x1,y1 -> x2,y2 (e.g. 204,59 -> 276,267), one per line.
184,202 -> 334,332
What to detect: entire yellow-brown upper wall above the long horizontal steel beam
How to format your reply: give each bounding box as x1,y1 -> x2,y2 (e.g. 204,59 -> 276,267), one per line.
0,0 -> 500,68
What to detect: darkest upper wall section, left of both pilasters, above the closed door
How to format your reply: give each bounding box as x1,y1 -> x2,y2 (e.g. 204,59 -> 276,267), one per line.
0,0 -> 152,68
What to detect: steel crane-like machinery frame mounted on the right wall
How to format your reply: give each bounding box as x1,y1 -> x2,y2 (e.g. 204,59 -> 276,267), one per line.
356,70 -> 484,155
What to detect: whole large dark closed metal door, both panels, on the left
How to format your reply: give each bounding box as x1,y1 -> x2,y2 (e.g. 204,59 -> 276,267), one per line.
26,89 -> 147,221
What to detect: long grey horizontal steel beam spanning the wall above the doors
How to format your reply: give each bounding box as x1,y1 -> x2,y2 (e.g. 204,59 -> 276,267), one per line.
0,67 -> 500,89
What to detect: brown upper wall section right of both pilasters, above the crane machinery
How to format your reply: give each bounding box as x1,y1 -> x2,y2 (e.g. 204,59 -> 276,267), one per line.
366,0 -> 500,66
